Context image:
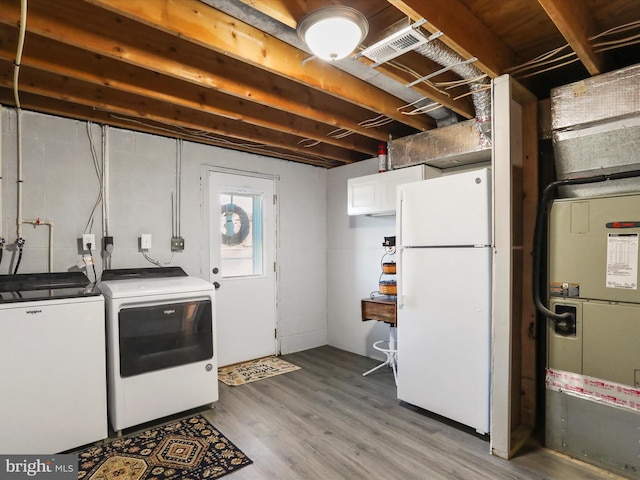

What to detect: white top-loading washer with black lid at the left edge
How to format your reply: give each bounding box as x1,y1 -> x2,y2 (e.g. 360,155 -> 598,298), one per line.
0,272 -> 108,454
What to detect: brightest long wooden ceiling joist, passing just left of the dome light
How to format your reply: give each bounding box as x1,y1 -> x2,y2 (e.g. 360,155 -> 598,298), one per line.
86,0 -> 435,130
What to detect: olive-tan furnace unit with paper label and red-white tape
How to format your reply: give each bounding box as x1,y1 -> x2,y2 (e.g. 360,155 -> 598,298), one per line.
545,194 -> 640,478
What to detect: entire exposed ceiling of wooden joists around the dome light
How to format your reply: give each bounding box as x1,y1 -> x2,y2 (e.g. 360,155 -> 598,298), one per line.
0,0 -> 640,168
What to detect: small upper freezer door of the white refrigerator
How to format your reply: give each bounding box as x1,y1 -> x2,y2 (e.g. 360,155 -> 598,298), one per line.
396,168 -> 491,246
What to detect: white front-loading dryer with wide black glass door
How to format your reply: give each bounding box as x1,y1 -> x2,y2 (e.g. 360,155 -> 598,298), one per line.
98,267 -> 218,433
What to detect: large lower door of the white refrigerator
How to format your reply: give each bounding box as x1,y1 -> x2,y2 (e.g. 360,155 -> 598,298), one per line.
398,247 -> 491,433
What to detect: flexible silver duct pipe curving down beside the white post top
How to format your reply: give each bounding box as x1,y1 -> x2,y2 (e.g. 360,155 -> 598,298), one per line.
415,39 -> 491,125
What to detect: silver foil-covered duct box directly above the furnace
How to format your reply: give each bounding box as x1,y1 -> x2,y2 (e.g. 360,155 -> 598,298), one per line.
551,65 -> 640,197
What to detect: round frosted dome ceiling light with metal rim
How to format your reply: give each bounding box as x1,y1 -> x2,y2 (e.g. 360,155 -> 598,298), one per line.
297,5 -> 369,61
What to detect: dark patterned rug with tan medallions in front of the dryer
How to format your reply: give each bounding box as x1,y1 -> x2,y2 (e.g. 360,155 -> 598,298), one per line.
78,415 -> 253,480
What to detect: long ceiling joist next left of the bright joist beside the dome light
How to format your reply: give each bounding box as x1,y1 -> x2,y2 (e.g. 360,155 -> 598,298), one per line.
0,0 -> 400,141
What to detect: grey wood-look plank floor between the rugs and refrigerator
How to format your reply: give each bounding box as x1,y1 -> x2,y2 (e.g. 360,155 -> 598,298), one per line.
201,346 -> 620,480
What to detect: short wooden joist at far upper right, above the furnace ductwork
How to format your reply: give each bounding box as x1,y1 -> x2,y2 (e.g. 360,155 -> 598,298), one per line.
538,0 -> 604,75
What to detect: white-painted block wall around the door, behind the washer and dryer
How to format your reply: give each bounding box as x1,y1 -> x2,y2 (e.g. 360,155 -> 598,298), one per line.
0,108 -> 327,353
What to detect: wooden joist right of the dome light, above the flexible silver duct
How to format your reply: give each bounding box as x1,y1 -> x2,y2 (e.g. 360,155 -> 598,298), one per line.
387,0 -> 520,78
